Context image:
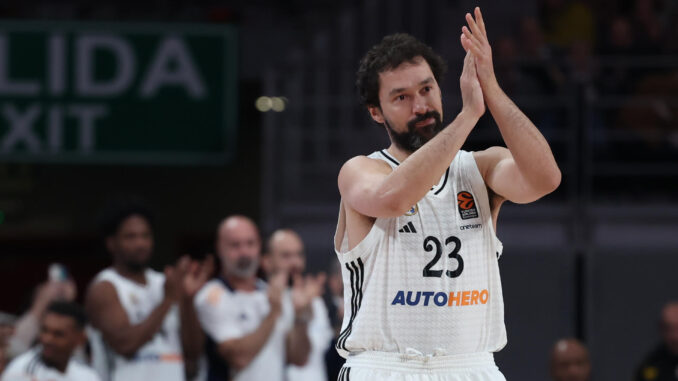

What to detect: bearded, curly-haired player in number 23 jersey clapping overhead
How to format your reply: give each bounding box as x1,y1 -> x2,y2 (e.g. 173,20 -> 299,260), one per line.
335,8 -> 560,381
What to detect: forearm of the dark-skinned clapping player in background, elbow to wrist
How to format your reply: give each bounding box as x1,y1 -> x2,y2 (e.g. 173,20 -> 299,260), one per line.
107,299 -> 172,357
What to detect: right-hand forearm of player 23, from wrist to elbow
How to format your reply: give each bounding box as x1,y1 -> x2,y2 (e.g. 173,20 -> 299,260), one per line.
483,81 -> 560,187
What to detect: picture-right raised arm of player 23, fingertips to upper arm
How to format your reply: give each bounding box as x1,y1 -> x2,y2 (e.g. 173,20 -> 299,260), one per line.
461,7 -> 561,203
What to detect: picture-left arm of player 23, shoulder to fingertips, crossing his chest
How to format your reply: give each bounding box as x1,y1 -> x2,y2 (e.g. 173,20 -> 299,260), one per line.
338,53 -> 485,217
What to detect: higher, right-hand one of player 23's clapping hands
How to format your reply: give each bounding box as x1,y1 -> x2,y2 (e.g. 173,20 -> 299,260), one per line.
461,7 -> 497,89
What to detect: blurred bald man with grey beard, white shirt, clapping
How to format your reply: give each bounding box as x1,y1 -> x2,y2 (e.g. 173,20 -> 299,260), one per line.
195,216 -> 317,381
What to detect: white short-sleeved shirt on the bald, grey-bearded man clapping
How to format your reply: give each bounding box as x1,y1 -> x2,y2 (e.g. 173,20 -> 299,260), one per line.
195,279 -> 294,381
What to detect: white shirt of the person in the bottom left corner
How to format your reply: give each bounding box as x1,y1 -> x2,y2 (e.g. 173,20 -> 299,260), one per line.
0,348 -> 100,381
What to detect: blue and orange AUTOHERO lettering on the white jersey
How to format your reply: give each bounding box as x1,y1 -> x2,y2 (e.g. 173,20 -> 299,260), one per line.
391,290 -> 490,307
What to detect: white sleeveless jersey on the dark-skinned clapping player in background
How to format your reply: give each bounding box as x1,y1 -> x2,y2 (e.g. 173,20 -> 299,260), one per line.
90,268 -> 185,381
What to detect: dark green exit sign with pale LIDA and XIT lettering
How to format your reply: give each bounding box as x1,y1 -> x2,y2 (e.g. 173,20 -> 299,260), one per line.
0,21 -> 237,164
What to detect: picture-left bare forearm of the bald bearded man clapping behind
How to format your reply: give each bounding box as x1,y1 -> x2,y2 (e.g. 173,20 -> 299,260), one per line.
219,313 -> 278,370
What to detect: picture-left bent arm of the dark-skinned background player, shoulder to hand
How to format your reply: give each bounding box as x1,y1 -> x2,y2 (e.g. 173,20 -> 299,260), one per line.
85,272 -> 178,357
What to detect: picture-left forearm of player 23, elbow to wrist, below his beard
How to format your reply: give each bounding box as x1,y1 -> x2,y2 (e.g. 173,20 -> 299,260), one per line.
377,111 -> 478,209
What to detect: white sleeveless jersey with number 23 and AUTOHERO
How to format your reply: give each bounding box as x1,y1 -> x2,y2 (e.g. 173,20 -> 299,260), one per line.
335,150 -> 506,357
